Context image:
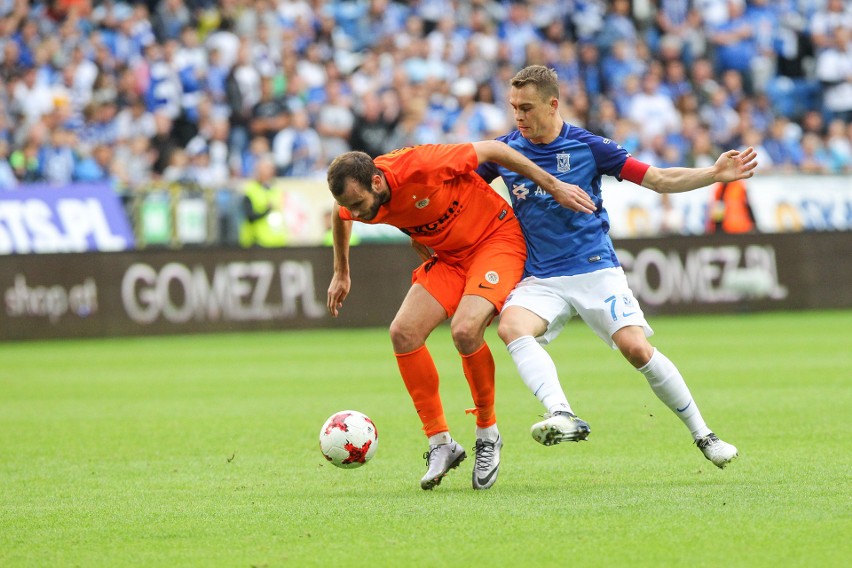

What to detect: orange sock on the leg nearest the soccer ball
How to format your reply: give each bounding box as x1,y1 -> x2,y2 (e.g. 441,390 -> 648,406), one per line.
396,345 -> 449,436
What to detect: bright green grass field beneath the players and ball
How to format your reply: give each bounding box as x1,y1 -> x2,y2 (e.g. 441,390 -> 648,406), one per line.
0,311 -> 852,567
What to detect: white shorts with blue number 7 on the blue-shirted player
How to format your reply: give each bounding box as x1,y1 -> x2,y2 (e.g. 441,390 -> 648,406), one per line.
503,267 -> 654,349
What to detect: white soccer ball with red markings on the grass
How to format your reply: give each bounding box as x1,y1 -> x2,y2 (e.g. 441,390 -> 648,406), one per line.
320,410 -> 379,469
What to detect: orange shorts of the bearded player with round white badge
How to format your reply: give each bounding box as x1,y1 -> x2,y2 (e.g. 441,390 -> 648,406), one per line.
411,225 -> 527,317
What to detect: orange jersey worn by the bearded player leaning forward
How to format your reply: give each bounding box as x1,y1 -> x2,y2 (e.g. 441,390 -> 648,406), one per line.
340,144 -> 517,256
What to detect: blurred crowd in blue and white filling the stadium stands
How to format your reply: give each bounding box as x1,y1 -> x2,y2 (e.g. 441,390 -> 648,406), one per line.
0,0 -> 852,191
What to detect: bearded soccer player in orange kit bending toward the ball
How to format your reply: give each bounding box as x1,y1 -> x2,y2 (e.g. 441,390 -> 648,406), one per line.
328,140 -> 594,489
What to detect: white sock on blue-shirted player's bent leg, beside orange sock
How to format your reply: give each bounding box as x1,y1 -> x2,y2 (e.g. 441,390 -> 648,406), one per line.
506,335 -> 573,414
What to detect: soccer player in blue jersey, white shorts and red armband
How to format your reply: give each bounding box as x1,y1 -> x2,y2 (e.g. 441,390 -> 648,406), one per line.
478,65 -> 757,468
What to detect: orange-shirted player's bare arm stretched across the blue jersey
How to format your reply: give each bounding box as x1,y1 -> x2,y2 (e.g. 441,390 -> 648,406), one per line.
473,140 -> 595,213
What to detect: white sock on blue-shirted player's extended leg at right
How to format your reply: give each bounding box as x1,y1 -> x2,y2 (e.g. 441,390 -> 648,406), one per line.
639,349 -> 710,440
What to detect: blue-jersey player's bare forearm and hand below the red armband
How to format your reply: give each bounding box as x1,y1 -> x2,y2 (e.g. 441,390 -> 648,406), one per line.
642,147 -> 757,193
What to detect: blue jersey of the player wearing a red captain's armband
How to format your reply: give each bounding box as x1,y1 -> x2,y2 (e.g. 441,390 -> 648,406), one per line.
477,123 -> 630,278
